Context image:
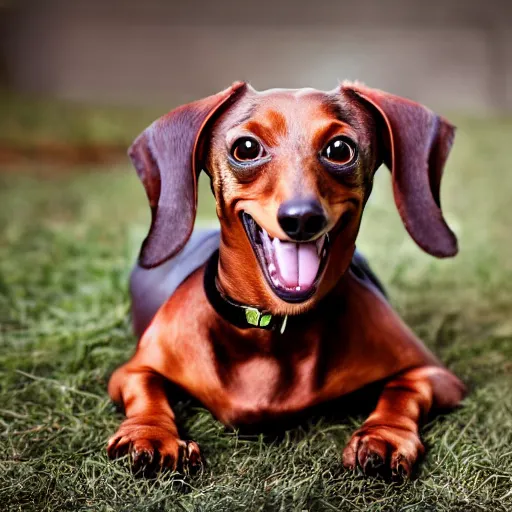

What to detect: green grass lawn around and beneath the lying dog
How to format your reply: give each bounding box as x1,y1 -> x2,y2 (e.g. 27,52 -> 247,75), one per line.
0,120 -> 512,512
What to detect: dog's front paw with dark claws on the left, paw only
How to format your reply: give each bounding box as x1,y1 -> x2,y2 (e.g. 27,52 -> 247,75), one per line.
107,418 -> 204,475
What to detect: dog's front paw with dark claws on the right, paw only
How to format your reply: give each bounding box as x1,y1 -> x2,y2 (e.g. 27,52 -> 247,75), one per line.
343,425 -> 425,481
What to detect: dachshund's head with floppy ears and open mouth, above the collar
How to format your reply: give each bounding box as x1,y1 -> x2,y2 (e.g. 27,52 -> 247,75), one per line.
129,83 -> 457,314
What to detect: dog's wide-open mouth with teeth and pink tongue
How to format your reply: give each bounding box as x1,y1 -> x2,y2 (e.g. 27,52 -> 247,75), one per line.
241,212 -> 329,302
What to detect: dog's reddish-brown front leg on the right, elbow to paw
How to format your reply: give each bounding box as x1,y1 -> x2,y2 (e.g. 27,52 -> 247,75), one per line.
343,366 -> 465,479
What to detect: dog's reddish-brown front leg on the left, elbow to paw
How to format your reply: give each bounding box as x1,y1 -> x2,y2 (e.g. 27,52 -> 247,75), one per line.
107,363 -> 202,470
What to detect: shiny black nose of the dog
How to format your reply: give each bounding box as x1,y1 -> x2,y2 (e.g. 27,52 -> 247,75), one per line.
277,199 -> 327,241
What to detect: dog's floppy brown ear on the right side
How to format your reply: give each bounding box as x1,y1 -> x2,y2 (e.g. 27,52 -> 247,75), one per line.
343,84 -> 458,258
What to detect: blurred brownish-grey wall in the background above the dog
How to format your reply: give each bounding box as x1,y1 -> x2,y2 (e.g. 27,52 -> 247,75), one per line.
0,0 -> 512,112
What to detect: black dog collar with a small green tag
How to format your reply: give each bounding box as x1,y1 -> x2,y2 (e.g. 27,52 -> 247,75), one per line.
204,250 -> 288,334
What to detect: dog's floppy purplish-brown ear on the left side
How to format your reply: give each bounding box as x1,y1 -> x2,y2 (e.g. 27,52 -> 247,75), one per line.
128,82 -> 245,268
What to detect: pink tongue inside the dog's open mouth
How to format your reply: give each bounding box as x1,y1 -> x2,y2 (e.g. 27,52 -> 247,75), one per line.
272,238 -> 320,288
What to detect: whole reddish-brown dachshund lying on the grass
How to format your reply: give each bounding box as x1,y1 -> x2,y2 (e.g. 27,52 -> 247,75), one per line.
108,83 -> 464,476
